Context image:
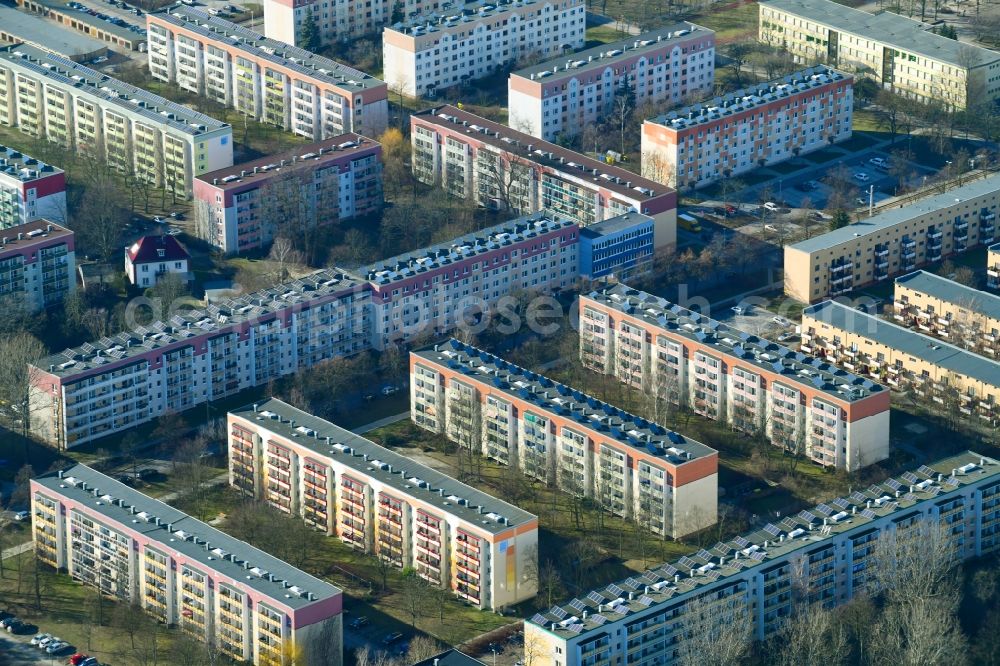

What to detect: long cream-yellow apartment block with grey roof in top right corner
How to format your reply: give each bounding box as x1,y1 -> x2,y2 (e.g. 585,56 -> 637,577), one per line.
759,0 -> 1000,109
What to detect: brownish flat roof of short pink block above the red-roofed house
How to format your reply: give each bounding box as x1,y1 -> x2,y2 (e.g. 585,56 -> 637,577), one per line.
195,132 -> 380,190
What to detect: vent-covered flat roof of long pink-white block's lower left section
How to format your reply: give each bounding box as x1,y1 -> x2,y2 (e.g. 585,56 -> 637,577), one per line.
34,269 -> 364,378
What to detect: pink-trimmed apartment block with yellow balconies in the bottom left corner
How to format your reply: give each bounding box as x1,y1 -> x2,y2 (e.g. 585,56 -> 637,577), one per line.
30,464 -> 343,666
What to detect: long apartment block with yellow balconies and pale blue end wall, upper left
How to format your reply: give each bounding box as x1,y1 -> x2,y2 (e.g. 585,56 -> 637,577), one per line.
0,44 -> 233,196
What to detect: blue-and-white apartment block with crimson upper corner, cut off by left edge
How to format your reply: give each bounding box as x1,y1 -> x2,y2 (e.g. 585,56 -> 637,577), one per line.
0,146 -> 69,229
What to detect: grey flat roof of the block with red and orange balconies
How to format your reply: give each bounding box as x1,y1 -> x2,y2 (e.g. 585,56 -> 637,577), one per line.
229,398 -> 538,534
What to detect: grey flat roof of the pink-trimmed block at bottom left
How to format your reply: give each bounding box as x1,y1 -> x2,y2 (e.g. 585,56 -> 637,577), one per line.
33,464 -> 342,610
